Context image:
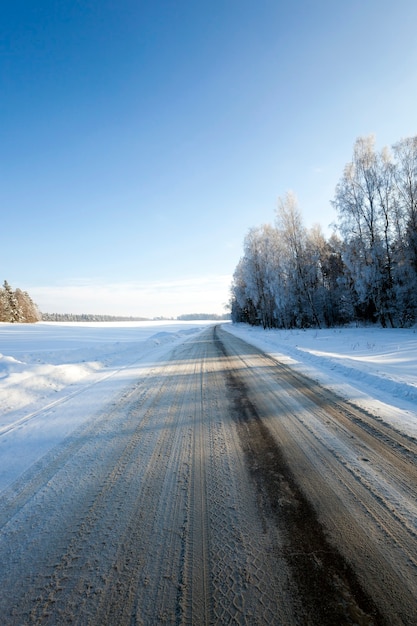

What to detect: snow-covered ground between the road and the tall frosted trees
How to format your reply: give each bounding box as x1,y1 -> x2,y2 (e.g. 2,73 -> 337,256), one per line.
224,324 -> 417,437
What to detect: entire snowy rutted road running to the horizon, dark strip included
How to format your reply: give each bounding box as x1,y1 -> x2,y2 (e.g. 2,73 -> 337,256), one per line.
0,327 -> 417,626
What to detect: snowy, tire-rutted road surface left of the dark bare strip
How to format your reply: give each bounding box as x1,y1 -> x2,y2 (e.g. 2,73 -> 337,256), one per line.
0,329 -> 394,626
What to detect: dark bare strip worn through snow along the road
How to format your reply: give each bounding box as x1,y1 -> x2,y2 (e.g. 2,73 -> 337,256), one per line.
216,326 -> 387,626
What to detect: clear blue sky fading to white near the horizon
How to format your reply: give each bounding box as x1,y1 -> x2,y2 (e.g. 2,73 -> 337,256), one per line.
0,0 -> 417,317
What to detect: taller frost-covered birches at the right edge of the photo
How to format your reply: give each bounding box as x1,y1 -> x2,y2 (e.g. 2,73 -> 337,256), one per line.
333,136 -> 417,326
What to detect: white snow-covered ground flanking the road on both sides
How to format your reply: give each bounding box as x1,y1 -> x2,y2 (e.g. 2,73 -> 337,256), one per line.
0,321 -> 417,490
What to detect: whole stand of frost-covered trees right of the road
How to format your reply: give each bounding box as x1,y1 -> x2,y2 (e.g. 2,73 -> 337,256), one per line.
231,136 -> 417,328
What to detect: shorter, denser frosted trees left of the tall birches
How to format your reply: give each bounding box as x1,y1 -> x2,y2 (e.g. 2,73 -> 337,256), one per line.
231,194 -> 348,328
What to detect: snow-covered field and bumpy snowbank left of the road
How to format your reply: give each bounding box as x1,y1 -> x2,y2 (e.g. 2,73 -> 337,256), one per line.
0,321 -> 213,492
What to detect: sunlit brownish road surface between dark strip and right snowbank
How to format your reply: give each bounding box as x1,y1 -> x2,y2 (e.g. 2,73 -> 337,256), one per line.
216,324 -> 417,626
